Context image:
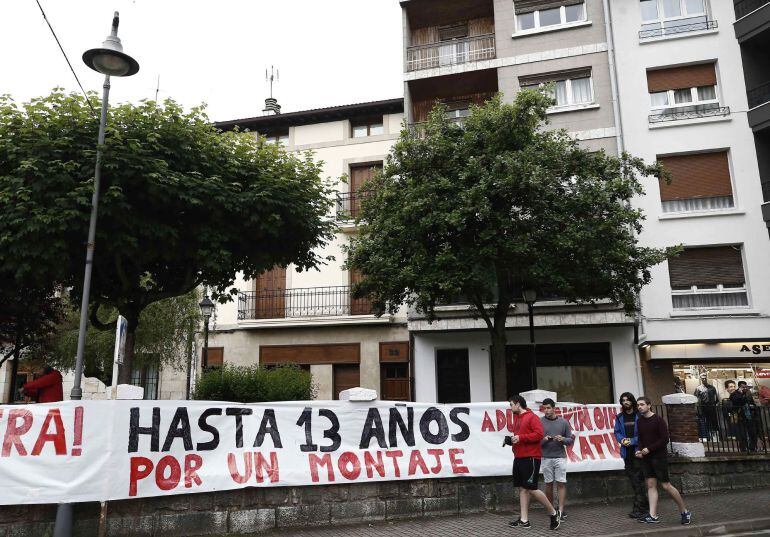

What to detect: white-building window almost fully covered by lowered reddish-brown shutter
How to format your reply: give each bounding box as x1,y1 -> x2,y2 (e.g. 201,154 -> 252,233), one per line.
658,151 -> 733,213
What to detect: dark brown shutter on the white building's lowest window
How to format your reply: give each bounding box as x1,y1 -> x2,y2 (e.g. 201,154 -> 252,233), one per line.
668,246 -> 746,288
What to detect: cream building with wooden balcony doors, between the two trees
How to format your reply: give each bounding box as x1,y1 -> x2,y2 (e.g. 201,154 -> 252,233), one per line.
207,98 -> 411,400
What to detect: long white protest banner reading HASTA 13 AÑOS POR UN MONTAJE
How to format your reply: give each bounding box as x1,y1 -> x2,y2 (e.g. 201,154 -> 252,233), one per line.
0,401 -> 623,505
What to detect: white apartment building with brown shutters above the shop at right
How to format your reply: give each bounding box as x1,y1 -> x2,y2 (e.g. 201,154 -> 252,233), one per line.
609,0 -> 770,397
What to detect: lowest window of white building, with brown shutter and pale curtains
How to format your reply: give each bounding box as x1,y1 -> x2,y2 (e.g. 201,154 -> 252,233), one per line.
668,246 -> 749,309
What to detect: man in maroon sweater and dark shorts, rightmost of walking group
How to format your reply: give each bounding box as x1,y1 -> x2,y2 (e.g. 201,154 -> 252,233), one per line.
635,396 -> 692,524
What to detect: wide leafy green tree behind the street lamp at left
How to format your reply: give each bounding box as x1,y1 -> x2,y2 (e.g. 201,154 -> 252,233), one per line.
0,90 -> 334,382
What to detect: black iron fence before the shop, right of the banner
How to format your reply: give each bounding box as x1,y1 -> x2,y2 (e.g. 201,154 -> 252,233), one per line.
697,403 -> 770,455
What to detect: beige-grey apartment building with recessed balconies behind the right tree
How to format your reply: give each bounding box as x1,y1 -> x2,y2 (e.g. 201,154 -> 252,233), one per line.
401,0 -> 642,403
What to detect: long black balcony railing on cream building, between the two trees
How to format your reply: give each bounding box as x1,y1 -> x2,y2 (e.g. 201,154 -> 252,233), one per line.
238,285 -> 373,321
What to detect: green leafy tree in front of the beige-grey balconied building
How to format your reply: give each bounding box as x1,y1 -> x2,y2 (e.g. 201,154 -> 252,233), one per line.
347,91 -> 674,397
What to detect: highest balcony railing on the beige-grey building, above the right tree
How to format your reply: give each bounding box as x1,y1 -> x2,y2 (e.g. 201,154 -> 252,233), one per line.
406,34 -> 495,71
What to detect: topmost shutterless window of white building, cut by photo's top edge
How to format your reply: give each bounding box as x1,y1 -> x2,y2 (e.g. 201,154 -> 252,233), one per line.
639,0 -> 713,38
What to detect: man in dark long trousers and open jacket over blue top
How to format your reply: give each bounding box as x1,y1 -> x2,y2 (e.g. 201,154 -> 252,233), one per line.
615,392 -> 650,518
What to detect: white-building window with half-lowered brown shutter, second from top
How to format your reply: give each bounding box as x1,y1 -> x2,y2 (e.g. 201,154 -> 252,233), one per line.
647,63 -> 730,122
